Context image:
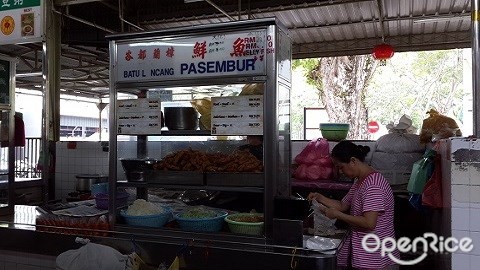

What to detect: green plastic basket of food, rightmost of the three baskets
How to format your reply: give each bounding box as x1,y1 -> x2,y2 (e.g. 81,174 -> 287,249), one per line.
225,213 -> 264,235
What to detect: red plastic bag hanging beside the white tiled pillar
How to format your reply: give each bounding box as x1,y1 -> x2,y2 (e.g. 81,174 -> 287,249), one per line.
422,155 -> 443,208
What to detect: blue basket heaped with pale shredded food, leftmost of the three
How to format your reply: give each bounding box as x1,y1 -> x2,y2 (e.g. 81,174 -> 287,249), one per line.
120,199 -> 172,228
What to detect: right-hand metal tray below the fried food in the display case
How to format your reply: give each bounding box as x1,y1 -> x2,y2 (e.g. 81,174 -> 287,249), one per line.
205,172 -> 265,187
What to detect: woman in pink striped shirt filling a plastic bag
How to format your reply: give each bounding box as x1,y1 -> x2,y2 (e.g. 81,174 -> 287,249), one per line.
308,140 -> 400,269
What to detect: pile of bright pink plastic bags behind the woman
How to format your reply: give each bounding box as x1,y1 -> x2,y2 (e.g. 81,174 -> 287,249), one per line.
293,138 -> 334,180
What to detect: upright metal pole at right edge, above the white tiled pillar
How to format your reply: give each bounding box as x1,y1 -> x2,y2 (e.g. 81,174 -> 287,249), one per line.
472,0 -> 480,137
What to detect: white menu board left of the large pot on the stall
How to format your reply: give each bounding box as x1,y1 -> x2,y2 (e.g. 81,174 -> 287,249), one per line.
117,98 -> 162,135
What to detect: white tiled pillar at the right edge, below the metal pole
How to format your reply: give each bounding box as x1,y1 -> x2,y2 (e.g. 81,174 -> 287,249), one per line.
440,138 -> 480,270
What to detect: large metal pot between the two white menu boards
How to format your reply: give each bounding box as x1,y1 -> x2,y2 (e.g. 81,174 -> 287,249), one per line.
164,107 -> 198,130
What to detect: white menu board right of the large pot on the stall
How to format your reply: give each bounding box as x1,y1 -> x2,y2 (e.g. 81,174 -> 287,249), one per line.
211,95 -> 263,135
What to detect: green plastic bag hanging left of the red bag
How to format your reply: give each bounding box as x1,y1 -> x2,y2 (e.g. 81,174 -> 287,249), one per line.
407,149 -> 437,194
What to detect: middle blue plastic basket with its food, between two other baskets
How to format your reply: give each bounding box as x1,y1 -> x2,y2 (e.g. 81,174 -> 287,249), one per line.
175,207 -> 228,232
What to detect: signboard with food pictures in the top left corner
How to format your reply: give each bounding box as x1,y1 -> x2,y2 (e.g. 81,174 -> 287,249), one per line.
0,0 -> 43,44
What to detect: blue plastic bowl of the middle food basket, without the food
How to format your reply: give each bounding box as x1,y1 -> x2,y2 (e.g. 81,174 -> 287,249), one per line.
175,211 -> 228,232
